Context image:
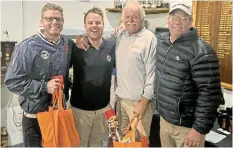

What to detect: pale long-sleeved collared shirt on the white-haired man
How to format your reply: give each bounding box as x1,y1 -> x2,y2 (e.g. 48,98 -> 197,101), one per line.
116,28 -> 157,101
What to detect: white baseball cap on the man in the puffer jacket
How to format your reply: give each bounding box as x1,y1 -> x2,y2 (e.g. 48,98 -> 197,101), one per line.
169,2 -> 192,15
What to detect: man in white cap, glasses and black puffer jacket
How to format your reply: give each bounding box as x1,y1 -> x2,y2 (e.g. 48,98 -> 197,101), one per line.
155,3 -> 222,147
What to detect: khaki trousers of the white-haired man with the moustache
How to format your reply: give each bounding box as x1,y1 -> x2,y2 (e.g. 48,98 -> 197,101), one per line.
116,96 -> 154,137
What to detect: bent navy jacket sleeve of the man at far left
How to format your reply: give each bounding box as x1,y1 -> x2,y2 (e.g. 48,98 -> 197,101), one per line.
5,41 -> 47,99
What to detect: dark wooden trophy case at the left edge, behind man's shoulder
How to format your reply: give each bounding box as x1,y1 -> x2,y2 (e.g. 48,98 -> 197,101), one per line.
1,41 -> 17,84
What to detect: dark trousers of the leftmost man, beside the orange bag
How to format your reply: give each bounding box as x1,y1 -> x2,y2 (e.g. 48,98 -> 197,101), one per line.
22,116 -> 41,147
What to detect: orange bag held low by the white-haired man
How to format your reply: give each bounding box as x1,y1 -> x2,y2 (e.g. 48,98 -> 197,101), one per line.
113,117 -> 149,147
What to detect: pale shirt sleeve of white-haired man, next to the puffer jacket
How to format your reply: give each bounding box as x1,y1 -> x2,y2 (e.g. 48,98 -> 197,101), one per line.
143,36 -> 157,100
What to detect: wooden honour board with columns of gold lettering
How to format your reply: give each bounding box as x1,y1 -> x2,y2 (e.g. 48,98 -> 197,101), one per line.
193,1 -> 232,89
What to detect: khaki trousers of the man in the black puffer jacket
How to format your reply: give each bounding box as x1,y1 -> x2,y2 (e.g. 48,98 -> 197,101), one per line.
160,116 -> 205,147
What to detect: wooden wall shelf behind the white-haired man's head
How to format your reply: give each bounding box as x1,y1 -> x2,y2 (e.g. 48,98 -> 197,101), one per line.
105,8 -> 169,14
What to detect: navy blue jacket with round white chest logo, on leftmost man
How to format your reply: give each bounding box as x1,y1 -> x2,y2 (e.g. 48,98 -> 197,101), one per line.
5,33 -> 73,113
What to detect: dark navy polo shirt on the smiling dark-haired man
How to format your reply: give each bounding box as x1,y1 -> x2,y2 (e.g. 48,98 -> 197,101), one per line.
70,39 -> 115,110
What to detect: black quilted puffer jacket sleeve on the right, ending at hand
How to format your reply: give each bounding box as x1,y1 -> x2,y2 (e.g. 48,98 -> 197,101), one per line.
191,47 -> 222,134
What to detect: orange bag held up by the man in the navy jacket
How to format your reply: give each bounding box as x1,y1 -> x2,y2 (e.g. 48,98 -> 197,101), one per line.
37,77 -> 80,147
